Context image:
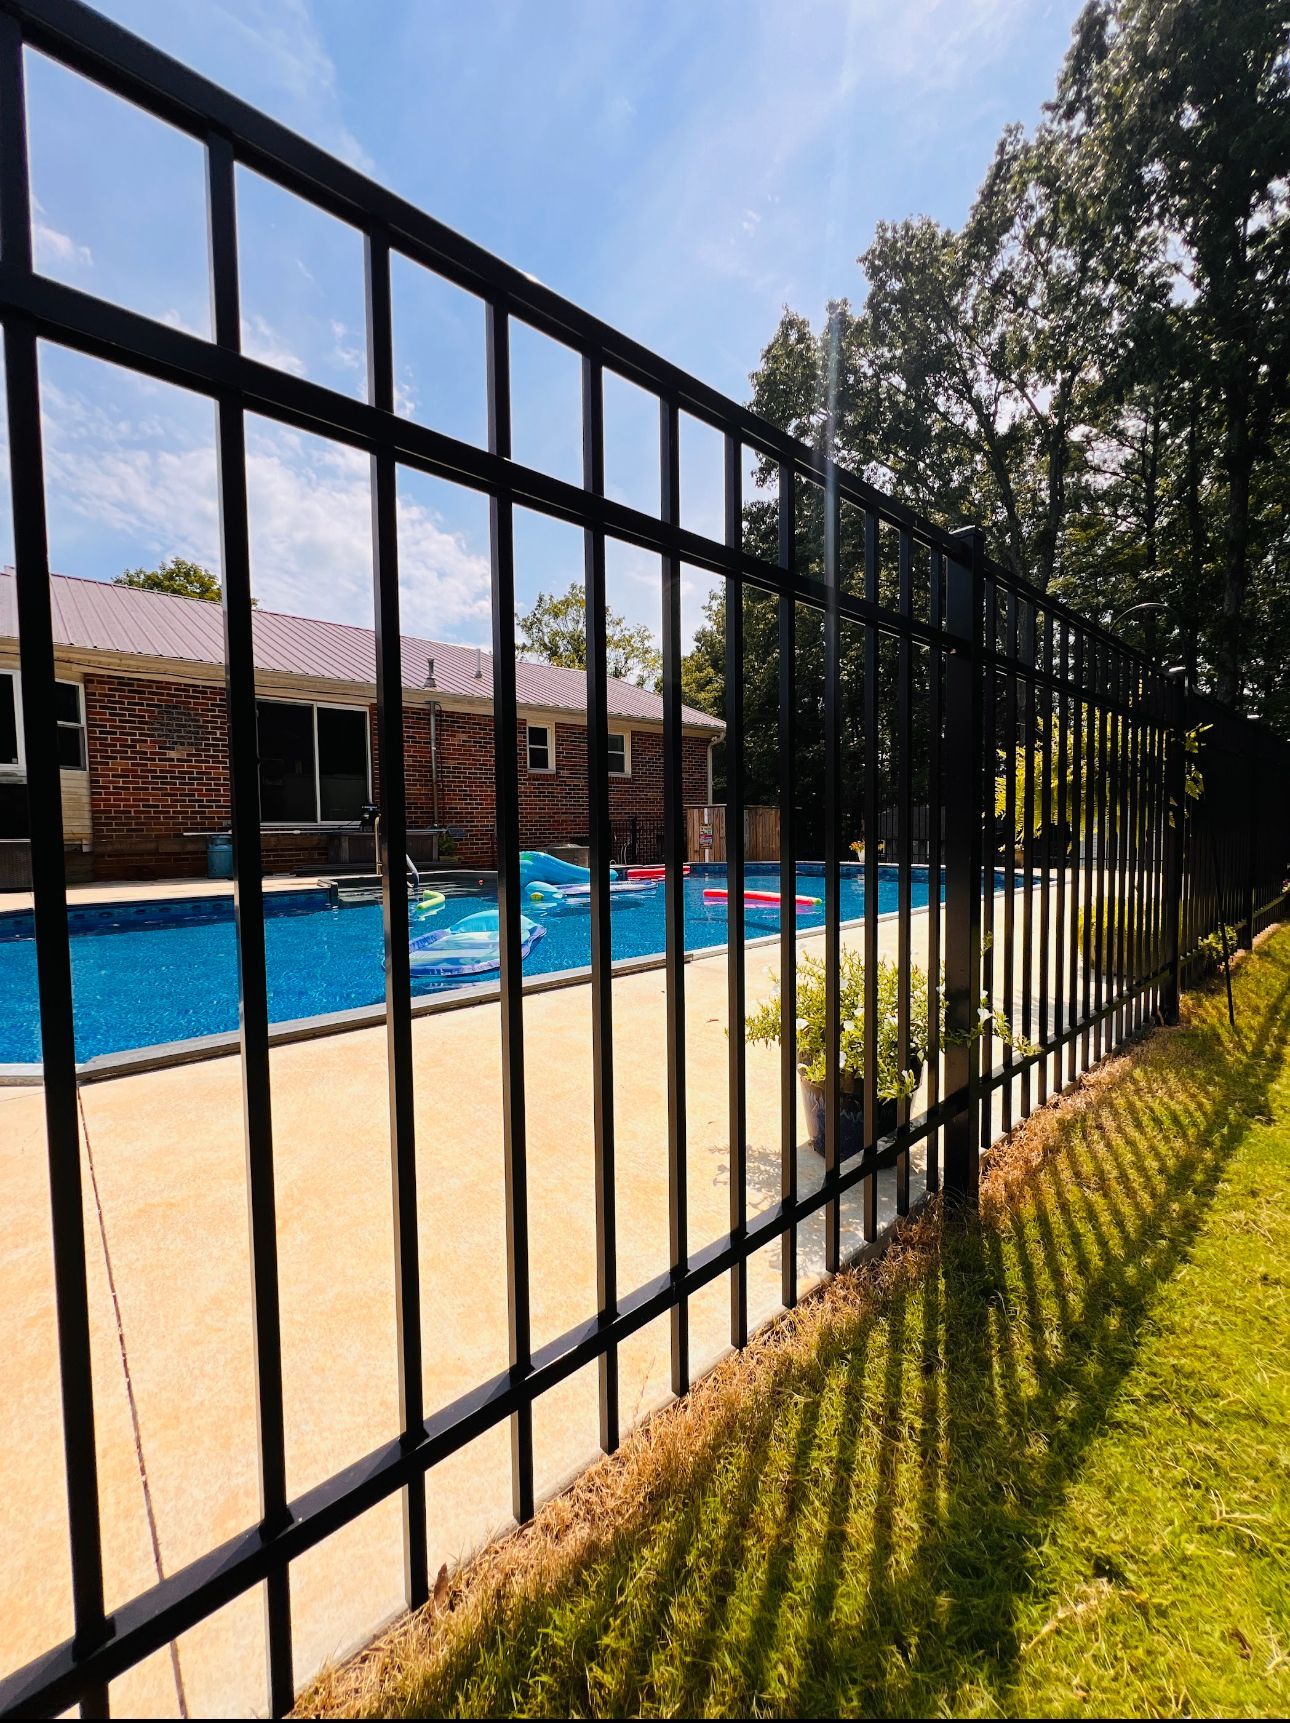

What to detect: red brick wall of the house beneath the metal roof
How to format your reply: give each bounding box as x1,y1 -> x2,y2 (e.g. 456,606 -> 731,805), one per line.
84,674 -> 708,879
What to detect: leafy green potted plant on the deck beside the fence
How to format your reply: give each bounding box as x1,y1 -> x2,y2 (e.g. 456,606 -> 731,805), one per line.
746,948 -> 1037,1160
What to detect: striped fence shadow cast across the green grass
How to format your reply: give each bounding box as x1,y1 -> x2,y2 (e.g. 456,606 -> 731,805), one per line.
353,948 -> 1290,1716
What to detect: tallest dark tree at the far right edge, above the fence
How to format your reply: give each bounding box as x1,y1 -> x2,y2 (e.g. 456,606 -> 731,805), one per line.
1056,0 -> 1290,703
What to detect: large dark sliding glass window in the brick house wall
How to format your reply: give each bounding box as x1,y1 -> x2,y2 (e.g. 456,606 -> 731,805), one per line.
255,700 -> 372,825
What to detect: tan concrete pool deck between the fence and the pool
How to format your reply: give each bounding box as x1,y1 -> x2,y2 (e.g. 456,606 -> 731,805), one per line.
0,882 -> 1074,1714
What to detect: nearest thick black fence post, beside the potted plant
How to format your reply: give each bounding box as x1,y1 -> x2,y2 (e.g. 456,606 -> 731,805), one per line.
942,527 -> 994,1208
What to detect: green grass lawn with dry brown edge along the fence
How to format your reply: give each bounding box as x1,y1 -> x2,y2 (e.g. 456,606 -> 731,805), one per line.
307,930 -> 1290,1716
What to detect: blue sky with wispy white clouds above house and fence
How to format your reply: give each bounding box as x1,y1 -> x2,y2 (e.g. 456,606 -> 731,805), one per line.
7,0 -> 1078,641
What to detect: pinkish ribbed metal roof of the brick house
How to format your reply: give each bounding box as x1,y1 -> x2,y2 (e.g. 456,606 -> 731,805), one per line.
0,569 -> 725,734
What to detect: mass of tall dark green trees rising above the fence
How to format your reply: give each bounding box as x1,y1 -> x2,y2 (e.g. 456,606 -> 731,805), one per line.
740,0 -> 1290,731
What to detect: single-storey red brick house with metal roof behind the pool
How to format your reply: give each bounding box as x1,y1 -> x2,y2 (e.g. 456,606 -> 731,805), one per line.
0,569 -> 722,879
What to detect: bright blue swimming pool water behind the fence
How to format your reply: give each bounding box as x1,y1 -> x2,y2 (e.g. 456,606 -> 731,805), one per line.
0,863 -> 928,1065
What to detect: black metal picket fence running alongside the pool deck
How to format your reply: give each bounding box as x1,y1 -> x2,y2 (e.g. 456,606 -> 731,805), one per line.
0,0 -> 1290,1714
